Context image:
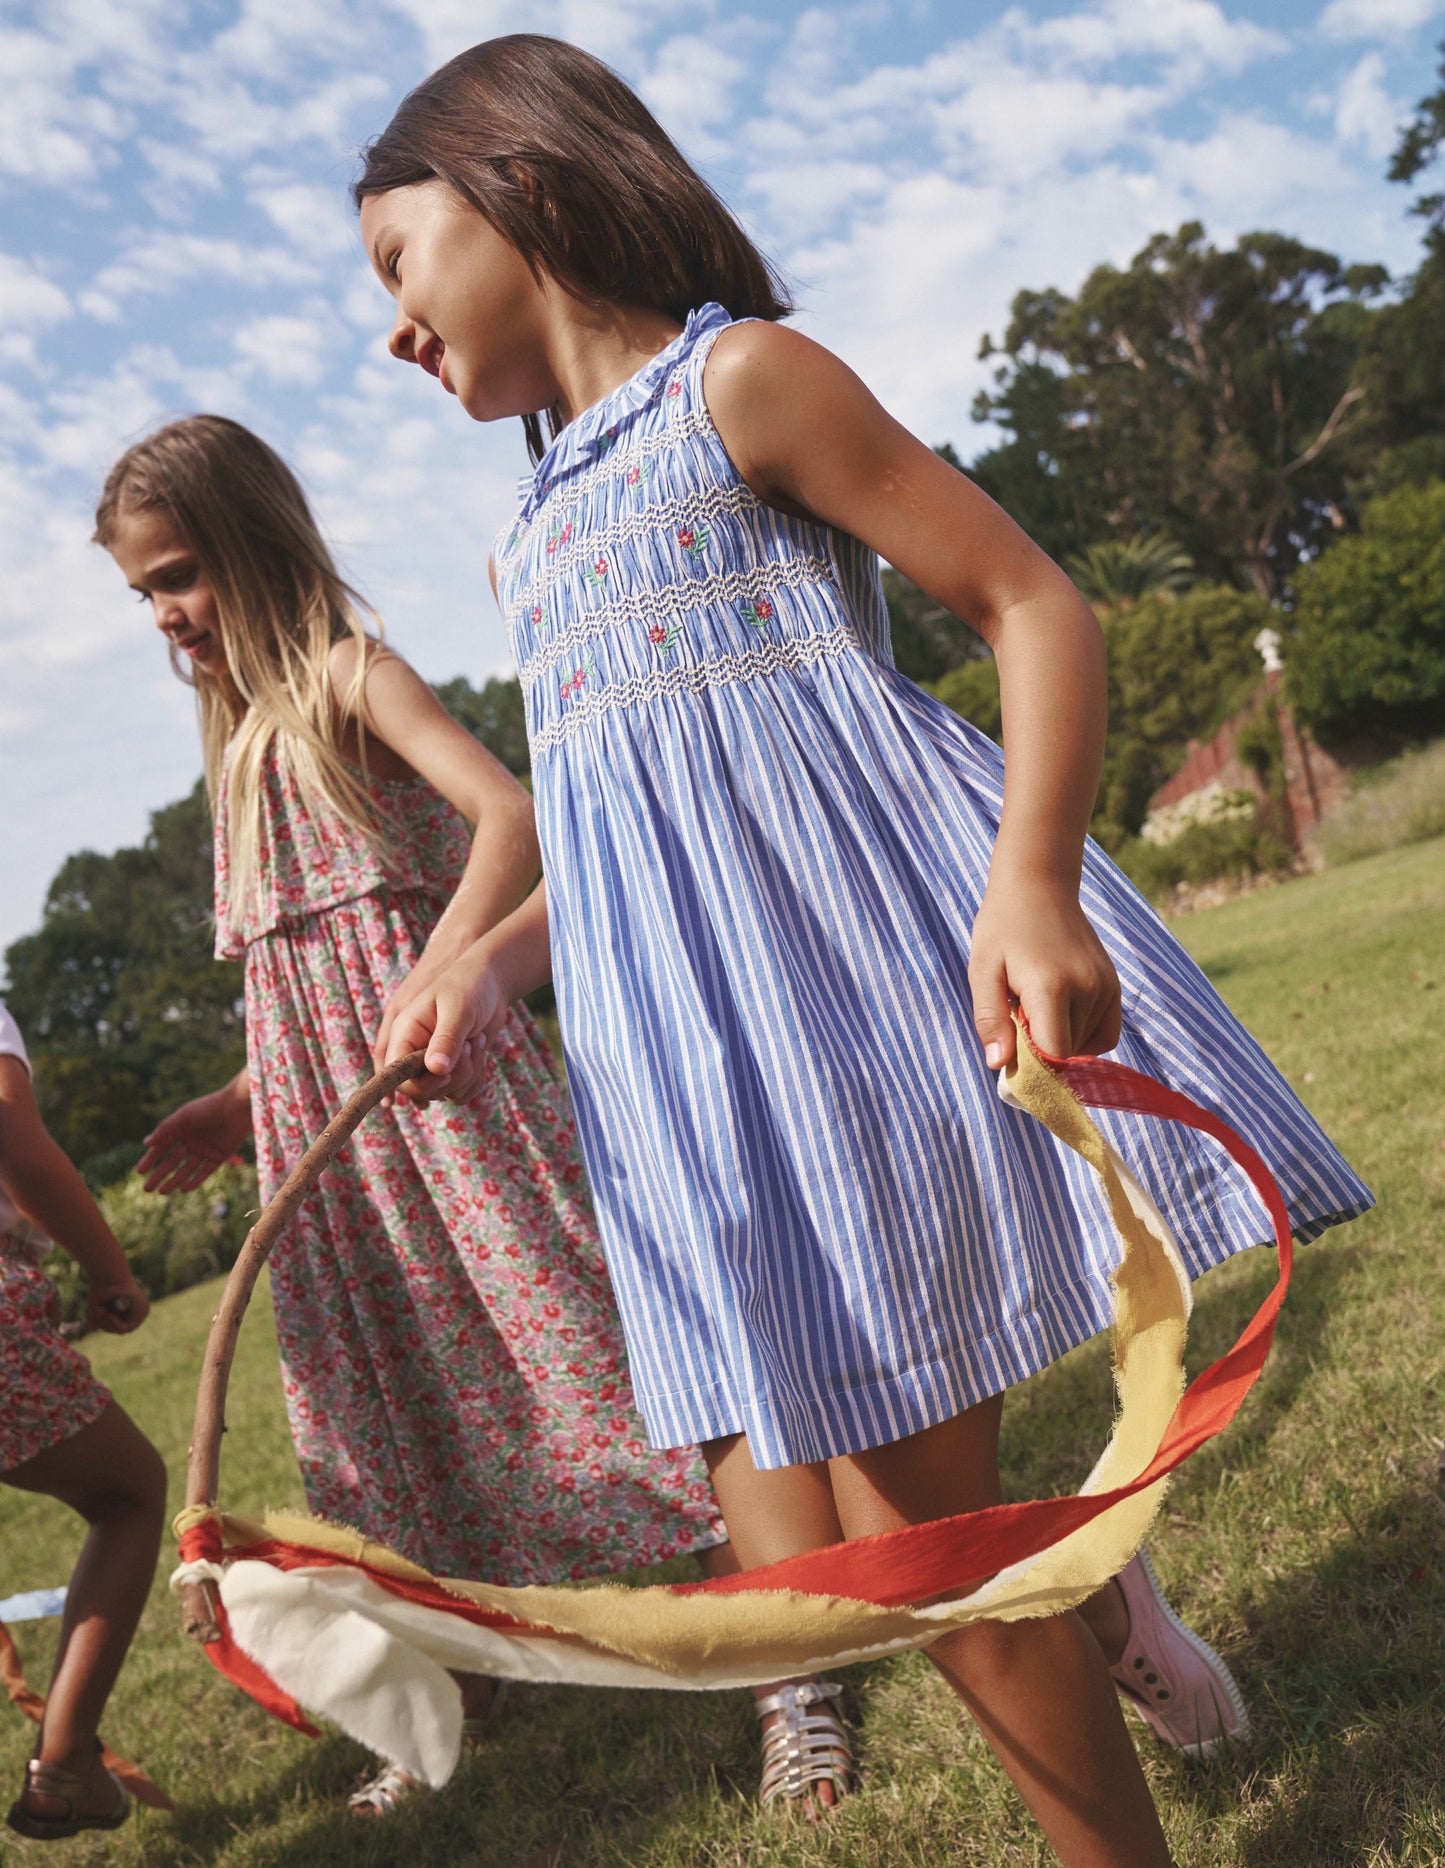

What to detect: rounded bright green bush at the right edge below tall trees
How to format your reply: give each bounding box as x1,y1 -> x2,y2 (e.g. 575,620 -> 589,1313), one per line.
1284,482 -> 1445,743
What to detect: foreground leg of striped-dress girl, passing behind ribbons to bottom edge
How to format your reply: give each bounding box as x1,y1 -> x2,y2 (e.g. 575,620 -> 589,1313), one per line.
831,1397 -> 1169,1868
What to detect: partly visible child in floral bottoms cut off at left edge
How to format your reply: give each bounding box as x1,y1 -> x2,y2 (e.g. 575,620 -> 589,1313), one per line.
0,1003 -> 166,1840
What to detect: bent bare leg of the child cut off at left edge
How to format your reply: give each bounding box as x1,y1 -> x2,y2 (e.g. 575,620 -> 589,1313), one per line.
2,1401 -> 166,1814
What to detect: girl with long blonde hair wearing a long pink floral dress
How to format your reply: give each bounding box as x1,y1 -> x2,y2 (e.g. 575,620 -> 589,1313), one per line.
95,415 -> 810,1814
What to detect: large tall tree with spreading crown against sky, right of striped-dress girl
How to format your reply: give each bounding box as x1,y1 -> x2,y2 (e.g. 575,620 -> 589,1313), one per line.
975,222 -> 1389,598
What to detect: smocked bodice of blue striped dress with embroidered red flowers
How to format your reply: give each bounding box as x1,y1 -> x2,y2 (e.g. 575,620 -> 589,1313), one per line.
495,304 -> 892,758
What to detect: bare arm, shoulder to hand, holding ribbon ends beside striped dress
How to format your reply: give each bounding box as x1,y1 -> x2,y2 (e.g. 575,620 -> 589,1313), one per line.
706,323 -> 1120,1065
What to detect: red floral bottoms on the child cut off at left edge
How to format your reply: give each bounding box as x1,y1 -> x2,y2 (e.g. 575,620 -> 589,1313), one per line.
0,1237 -> 110,1474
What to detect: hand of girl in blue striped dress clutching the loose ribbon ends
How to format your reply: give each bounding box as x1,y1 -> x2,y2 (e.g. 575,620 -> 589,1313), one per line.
969,878 -> 1122,1070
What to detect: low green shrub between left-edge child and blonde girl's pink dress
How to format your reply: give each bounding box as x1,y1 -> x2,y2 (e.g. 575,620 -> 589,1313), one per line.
45,1162 -> 260,1319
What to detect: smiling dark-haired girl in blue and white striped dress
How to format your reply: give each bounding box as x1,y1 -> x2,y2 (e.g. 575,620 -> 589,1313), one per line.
357,35 -> 1368,1868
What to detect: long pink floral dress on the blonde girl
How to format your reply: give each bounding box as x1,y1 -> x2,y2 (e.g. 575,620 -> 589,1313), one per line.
215,755 -> 724,1584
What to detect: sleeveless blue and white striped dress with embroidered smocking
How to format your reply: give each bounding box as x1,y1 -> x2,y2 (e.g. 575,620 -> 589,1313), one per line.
495,306 -> 1370,1466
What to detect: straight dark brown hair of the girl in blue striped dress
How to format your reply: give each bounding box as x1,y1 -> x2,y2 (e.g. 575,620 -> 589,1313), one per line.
351,32 -> 793,460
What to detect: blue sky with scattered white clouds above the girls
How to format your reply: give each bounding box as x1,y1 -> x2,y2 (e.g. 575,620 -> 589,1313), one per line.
0,0 -> 1445,945
